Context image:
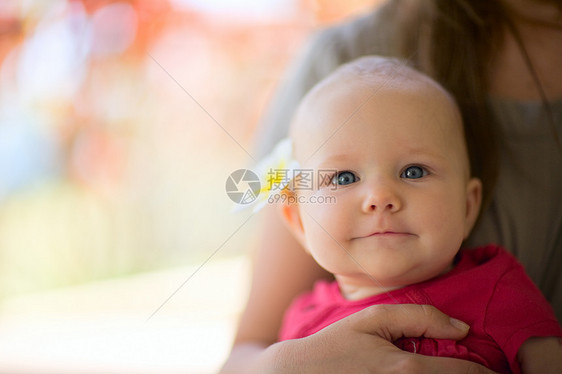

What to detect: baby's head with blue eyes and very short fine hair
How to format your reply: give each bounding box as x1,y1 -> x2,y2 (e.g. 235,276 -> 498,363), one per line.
283,57 -> 481,298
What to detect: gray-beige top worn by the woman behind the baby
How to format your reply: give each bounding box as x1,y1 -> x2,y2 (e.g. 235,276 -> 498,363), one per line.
256,2 -> 562,321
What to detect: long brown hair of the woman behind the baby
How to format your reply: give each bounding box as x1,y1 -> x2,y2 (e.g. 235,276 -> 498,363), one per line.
396,0 -> 562,208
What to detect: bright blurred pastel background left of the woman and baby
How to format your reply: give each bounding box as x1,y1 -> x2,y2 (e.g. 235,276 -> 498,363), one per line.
0,0 -> 377,374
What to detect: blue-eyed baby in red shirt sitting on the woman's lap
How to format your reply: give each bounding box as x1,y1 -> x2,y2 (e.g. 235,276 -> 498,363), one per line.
274,57 -> 562,373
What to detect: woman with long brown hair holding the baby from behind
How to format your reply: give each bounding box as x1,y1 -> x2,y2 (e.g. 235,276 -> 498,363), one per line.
222,0 -> 562,373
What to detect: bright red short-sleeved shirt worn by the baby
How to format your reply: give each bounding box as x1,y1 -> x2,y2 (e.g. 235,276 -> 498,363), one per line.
280,245 -> 562,373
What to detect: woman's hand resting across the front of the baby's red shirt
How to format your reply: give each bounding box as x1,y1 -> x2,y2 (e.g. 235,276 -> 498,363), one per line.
230,304 -> 493,374
